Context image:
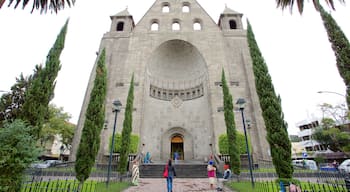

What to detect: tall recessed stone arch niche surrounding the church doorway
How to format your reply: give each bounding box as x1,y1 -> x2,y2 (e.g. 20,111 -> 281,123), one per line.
140,39 -> 213,161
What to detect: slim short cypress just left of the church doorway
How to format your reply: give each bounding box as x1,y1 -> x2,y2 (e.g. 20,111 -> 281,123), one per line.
118,74 -> 134,173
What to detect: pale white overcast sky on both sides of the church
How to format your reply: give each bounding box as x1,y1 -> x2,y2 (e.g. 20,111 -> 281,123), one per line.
0,0 -> 350,134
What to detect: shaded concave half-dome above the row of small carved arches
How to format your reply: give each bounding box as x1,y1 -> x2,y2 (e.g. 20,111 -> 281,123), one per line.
147,39 -> 207,87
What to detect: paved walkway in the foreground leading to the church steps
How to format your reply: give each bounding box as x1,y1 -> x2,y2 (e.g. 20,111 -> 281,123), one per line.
124,178 -> 232,192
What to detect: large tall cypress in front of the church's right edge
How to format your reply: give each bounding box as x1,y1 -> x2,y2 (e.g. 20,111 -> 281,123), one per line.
247,21 -> 293,178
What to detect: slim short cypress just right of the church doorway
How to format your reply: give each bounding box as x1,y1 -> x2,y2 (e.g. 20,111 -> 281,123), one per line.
221,69 -> 241,175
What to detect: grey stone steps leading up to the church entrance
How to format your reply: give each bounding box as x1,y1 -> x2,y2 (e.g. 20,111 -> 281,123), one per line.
139,162 -> 207,178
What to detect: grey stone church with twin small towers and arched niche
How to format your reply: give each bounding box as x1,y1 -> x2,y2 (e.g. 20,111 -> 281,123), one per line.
71,0 -> 271,162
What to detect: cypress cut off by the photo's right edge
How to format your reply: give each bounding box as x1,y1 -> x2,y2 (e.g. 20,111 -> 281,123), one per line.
319,5 -> 350,109
